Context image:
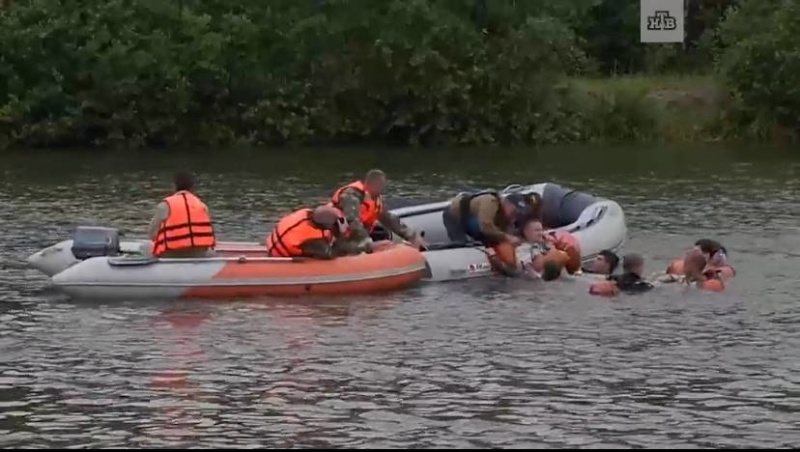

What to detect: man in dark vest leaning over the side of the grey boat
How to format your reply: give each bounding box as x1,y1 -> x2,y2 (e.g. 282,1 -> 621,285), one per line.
442,191 -> 541,269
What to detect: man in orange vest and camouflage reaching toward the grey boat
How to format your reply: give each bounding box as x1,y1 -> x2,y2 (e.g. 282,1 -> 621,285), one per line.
331,169 -> 426,252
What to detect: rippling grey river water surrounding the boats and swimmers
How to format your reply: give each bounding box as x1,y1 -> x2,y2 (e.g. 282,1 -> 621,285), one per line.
0,146 -> 800,448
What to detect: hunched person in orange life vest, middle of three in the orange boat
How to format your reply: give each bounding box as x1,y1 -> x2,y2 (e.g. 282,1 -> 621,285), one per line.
266,205 -> 358,259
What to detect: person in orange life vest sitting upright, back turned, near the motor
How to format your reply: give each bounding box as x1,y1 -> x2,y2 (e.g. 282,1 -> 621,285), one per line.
148,172 -> 216,257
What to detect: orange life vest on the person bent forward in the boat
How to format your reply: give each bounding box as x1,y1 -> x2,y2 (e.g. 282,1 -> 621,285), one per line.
266,209 -> 333,257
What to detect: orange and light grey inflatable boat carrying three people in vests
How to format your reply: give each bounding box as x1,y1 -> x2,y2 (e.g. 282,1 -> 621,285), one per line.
47,243 -> 425,300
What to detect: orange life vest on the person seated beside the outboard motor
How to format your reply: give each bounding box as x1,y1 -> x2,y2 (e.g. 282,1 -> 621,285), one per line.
151,191 -> 216,257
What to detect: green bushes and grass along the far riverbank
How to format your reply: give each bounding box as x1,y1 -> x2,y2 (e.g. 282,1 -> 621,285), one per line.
0,0 -> 800,150
